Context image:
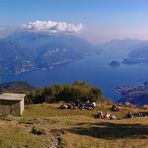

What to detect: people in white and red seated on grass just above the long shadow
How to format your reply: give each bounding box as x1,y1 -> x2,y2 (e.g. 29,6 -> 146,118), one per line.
96,111 -> 117,120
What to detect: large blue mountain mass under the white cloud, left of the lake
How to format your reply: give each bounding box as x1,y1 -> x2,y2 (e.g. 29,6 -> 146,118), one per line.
0,31 -> 97,73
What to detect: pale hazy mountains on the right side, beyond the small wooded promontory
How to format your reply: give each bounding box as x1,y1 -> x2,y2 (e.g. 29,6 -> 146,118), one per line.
99,39 -> 148,65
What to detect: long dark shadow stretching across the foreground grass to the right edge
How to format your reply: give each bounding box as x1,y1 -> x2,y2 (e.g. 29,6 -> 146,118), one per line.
68,122 -> 148,140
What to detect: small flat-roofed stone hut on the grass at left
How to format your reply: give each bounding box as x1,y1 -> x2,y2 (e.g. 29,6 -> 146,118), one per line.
0,93 -> 25,116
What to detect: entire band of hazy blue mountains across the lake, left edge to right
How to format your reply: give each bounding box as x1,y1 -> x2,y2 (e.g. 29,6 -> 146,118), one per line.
0,30 -> 148,73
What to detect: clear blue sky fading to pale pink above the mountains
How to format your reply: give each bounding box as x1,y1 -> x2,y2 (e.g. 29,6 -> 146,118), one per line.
0,0 -> 148,44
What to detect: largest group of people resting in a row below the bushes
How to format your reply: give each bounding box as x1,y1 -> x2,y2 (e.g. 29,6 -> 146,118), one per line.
59,101 -> 96,110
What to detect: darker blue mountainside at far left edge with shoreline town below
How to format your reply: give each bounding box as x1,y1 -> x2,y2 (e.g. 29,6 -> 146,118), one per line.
0,40 -> 33,73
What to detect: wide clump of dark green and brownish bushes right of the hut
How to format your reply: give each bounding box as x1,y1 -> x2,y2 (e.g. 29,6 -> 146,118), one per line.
25,81 -> 105,104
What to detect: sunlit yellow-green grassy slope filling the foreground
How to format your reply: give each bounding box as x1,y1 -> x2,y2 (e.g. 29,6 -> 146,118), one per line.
0,104 -> 148,148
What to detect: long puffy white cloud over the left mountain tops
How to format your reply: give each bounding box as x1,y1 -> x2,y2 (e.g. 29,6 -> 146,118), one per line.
21,21 -> 83,33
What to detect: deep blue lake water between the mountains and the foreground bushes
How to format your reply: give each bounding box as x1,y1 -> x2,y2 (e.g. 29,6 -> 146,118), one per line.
0,54 -> 148,101
